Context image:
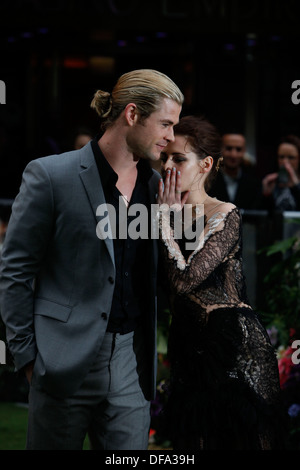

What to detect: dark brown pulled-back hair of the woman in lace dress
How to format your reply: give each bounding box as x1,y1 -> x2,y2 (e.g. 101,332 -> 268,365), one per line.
174,116 -> 222,190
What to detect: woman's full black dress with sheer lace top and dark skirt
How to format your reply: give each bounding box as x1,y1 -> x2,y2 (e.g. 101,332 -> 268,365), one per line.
159,206 -> 281,449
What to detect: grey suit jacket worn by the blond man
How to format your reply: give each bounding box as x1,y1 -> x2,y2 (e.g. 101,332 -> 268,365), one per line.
0,143 -> 159,396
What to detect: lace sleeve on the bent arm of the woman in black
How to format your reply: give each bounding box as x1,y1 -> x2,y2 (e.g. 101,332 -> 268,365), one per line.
159,207 -> 241,293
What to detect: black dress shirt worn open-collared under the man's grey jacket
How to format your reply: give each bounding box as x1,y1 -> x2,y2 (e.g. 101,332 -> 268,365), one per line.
91,136 -> 152,334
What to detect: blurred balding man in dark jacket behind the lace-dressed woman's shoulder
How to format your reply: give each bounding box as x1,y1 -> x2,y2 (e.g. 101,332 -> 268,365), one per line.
209,133 -> 261,209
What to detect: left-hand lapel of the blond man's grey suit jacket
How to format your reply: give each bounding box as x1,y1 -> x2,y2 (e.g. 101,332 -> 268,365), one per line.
79,144 -> 115,264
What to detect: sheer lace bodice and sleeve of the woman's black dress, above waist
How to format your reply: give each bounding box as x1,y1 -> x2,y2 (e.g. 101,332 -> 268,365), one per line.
159,203 -> 247,311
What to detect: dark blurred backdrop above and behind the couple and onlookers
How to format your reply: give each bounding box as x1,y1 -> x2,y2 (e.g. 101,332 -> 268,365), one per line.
0,0 -> 300,199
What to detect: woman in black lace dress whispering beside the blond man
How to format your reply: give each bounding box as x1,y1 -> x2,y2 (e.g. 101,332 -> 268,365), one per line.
158,116 -> 282,450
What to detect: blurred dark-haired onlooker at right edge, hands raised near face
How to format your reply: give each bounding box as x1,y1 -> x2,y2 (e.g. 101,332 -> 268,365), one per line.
262,135 -> 300,211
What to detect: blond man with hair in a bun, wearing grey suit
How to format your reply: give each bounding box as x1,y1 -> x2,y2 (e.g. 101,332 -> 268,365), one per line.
0,70 -> 183,450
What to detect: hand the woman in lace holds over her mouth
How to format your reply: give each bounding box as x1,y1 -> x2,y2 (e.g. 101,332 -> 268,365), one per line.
157,168 -> 189,210
